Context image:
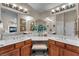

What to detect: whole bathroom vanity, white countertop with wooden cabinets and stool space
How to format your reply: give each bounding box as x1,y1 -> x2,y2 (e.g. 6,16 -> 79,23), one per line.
0,35 -> 79,56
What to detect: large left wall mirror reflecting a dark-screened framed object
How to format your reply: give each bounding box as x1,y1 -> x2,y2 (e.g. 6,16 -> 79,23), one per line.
1,8 -> 18,33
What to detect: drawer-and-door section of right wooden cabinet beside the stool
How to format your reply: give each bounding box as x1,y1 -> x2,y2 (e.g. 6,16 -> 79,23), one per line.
48,40 -> 59,56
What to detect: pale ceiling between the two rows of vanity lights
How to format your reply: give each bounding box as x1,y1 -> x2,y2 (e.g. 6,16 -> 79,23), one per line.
28,3 -> 62,12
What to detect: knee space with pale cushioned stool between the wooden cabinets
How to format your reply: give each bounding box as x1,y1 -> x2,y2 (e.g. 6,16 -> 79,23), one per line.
32,41 -> 48,56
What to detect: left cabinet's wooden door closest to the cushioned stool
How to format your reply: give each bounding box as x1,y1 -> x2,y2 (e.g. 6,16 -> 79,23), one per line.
21,44 -> 32,56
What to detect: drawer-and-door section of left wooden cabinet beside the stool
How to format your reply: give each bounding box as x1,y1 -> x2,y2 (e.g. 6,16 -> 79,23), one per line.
21,39 -> 32,56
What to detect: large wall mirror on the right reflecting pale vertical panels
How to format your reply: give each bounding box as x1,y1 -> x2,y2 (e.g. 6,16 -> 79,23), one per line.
56,10 -> 77,36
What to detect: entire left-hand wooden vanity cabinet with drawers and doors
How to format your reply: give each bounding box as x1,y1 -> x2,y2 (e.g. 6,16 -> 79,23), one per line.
0,39 -> 32,56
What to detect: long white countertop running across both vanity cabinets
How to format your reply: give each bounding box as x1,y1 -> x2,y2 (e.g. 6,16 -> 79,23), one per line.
0,35 -> 79,47
